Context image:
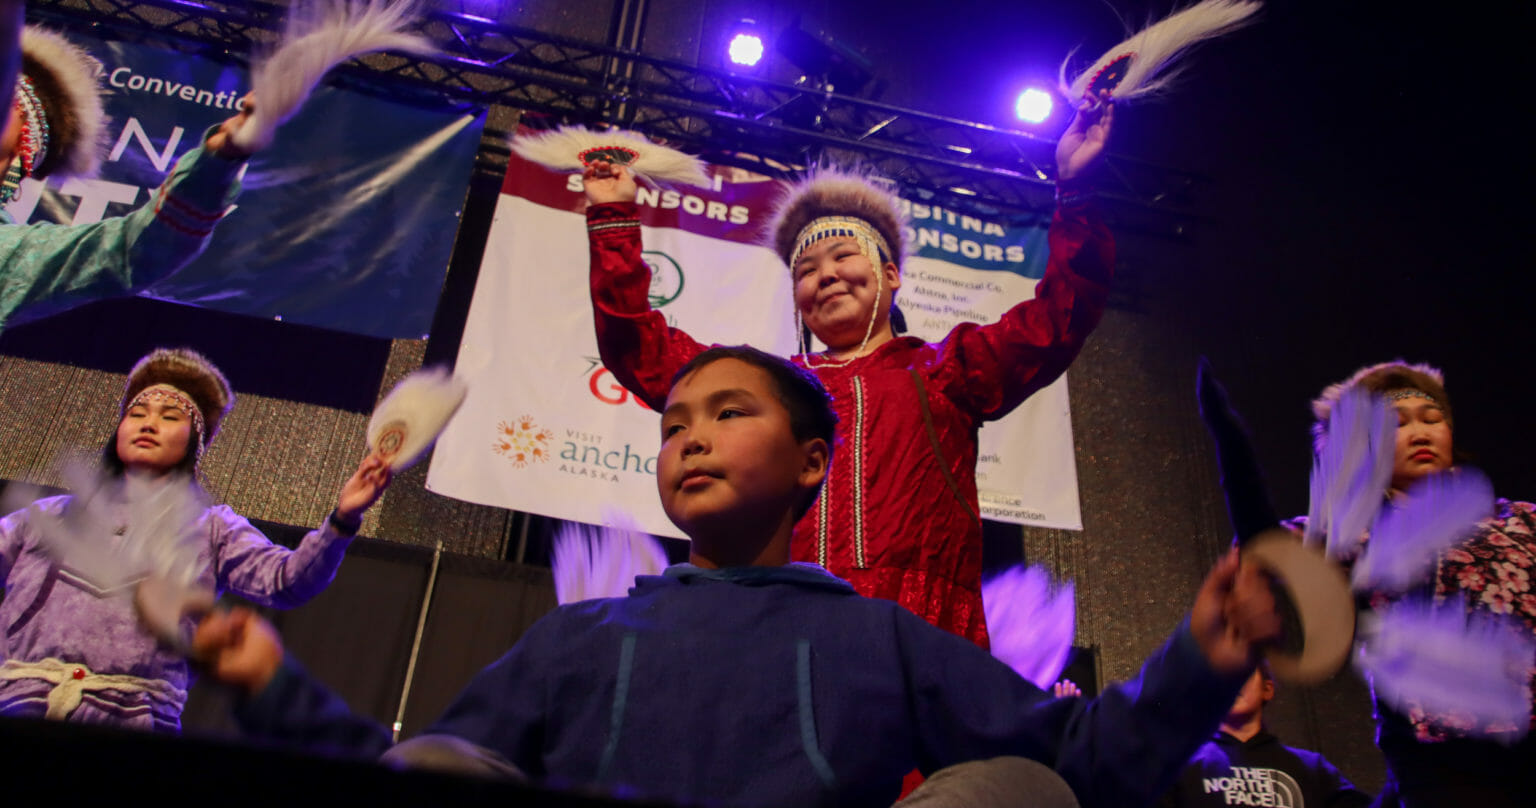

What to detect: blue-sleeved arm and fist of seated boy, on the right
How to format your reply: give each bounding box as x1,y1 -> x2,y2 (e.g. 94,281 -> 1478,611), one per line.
899,553 -> 1279,808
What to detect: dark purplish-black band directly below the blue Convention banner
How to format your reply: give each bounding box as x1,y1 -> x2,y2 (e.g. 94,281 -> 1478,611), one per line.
0,298 -> 390,413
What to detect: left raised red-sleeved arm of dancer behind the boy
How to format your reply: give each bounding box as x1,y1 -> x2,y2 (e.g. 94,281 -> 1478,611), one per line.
582,163 -> 703,412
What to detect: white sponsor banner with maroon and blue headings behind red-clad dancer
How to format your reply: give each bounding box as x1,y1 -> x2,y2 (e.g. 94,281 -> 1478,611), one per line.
427,155 -> 1081,536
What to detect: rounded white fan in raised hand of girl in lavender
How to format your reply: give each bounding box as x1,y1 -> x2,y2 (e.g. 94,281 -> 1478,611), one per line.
369,367 -> 468,472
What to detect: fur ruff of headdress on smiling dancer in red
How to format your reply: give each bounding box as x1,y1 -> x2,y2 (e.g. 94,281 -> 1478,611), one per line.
768,167 -> 906,266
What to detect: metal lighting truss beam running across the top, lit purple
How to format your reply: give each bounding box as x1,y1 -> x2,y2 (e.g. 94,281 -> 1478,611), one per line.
28,0 -> 1203,235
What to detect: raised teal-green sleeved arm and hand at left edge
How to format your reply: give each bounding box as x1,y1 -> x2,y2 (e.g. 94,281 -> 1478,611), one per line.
0,100 -> 258,330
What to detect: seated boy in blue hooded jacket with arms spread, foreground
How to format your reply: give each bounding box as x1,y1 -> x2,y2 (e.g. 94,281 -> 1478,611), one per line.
197,347 -> 1279,808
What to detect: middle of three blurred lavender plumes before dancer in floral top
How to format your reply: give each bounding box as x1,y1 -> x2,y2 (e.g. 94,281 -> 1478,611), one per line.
1350,469 -> 1493,593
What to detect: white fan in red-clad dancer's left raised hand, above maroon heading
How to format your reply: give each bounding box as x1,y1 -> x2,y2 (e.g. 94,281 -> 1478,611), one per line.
511,126 -> 710,187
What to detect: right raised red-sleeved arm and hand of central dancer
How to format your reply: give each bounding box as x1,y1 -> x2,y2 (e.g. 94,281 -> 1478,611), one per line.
937,100 -> 1115,421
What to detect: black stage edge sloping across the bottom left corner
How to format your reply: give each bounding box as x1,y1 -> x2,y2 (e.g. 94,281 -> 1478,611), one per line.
0,717 -> 672,808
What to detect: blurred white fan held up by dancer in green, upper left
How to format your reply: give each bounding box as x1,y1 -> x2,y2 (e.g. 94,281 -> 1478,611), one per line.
233,0 -> 433,152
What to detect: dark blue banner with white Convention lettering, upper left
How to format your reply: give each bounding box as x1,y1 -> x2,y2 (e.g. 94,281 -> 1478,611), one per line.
14,35 -> 484,338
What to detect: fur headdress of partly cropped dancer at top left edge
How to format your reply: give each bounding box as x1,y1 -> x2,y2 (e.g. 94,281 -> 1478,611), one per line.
17,26 -> 106,180
